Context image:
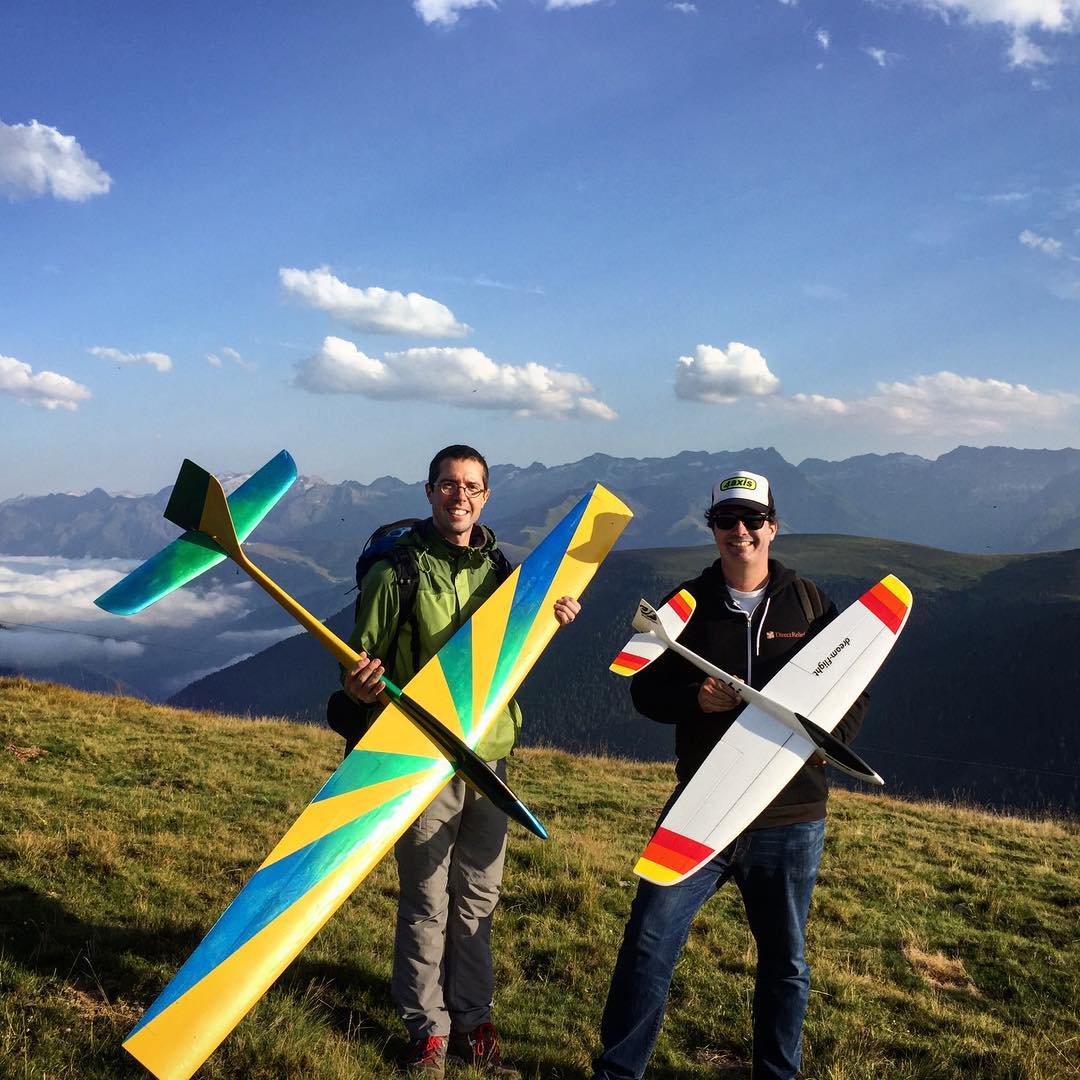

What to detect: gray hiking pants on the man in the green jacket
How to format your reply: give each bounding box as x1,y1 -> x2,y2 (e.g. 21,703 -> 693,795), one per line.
390,760 -> 507,1039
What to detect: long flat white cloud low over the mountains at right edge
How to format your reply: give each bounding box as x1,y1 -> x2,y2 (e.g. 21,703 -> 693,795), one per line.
784,372 -> 1080,438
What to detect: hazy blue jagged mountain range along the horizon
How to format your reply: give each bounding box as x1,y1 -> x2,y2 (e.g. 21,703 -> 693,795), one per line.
6,447 -> 1080,561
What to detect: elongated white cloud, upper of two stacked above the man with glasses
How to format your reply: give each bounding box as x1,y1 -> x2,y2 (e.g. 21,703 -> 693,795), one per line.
278,267 -> 470,338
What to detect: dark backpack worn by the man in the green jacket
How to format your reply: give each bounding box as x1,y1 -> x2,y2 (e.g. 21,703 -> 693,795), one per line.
326,517 -> 513,756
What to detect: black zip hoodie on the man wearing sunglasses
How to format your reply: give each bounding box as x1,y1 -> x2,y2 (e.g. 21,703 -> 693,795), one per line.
631,558 -> 868,828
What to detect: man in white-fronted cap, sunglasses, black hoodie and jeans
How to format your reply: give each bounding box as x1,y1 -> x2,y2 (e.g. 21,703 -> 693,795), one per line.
594,472 -> 866,1080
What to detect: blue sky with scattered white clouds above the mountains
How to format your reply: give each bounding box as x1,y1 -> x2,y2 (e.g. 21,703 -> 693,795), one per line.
0,0 -> 1080,499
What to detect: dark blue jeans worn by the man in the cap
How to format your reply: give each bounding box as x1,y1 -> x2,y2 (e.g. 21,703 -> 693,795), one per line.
593,821 -> 825,1080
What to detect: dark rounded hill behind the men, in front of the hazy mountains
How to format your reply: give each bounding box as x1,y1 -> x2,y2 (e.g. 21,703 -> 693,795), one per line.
171,535 -> 1080,814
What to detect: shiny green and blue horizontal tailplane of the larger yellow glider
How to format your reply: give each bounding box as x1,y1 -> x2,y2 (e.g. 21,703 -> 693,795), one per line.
94,450 -> 296,615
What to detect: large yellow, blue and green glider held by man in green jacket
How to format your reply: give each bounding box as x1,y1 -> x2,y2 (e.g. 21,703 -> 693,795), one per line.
97,454 -> 632,1080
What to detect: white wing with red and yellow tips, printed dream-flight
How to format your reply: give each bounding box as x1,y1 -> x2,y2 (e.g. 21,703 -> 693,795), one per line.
634,575 -> 912,885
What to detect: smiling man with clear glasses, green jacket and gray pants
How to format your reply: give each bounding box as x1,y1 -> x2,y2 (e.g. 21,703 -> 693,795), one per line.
345,444 -> 580,1078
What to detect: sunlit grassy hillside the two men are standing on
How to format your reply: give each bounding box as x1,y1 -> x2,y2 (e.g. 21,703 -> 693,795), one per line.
0,679 -> 1080,1080
